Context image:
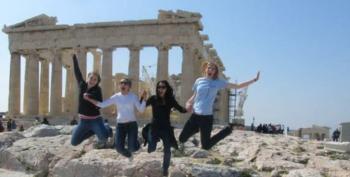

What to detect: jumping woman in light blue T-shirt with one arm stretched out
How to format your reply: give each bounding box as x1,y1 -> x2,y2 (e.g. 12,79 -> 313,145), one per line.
179,62 -> 260,150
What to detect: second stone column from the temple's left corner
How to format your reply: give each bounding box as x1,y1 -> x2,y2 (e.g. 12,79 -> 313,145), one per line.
24,50 -> 39,115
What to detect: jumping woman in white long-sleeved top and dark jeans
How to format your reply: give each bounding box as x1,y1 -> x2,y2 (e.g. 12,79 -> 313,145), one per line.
84,78 -> 147,157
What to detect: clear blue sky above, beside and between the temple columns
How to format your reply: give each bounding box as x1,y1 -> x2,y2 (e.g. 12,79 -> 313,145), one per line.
0,0 -> 350,128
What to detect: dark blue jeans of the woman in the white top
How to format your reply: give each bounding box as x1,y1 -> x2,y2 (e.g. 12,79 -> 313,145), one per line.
115,122 -> 140,157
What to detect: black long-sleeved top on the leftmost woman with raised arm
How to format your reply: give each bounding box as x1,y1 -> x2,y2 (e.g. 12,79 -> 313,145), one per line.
73,55 -> 102,116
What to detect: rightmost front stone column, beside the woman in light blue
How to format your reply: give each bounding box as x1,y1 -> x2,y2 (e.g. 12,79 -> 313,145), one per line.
180,44 -> 200,105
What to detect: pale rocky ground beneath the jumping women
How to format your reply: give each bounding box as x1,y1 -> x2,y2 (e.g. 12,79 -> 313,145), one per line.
0,125 -> 350,177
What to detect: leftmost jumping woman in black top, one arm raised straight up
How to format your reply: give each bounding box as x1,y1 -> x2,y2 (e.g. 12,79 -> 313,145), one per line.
71,55 -> 110,148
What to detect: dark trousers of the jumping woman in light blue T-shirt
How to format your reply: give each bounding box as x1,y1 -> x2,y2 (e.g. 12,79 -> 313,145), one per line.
179,114 -> 232,150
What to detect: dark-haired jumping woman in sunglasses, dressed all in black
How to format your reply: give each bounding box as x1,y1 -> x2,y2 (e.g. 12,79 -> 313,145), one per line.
146,80 -> 187,176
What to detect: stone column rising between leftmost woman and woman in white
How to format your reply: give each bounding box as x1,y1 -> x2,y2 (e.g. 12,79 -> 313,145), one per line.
101,48 -> 114,115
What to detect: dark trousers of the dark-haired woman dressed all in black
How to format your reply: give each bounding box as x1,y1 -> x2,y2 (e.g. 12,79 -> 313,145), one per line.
148,129 -> 171,174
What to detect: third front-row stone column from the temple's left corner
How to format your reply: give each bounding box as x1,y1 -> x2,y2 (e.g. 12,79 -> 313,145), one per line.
50,49 -> 62,115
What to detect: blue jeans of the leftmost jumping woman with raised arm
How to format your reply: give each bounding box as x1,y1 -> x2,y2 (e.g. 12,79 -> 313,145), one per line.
71,117 -> 110,146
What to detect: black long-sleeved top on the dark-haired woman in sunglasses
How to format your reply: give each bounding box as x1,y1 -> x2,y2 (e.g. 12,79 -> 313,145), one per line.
146,95 -> 187,130
